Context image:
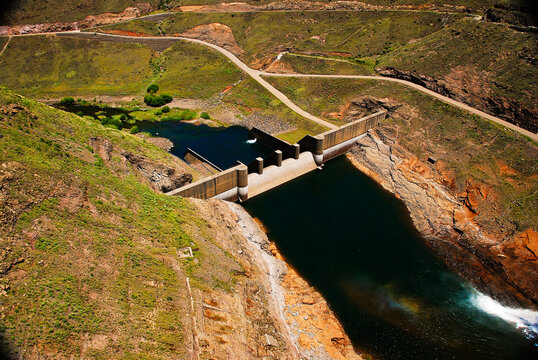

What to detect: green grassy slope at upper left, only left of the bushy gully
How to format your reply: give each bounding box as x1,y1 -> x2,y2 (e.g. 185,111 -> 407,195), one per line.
0,36 -> 155,97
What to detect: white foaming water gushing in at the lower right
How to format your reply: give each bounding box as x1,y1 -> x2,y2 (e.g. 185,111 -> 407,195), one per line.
471,291 -> 538,346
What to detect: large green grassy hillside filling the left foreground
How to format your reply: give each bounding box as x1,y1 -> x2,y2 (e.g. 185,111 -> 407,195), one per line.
0,88 -> 240,359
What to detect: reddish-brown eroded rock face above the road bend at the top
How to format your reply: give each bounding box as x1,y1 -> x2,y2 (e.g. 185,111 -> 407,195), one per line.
176,23 -> 244,55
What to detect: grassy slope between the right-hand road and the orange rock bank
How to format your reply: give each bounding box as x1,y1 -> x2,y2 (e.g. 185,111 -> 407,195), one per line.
268,78 -> 538,233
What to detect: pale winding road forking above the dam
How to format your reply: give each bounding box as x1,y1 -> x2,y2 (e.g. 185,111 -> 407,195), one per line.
2,31 -> 538,142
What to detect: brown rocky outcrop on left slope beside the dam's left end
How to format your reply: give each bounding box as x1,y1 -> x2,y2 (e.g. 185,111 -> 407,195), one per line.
89,137 -> 192,192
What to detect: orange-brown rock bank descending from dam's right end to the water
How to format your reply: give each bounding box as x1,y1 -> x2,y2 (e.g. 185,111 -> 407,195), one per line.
349,129 -> 538,307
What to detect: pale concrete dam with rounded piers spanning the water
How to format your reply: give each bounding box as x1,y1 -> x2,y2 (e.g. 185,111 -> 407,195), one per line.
167,110 -> 387,201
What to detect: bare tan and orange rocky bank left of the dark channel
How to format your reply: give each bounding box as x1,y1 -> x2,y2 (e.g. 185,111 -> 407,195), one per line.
190,199 -> 361,359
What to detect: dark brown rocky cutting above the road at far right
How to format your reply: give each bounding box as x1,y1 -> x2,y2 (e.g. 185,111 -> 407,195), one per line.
376,67 -> 538,133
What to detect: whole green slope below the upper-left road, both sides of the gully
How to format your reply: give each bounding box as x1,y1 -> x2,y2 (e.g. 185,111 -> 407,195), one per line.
0,36 -> 241,98
